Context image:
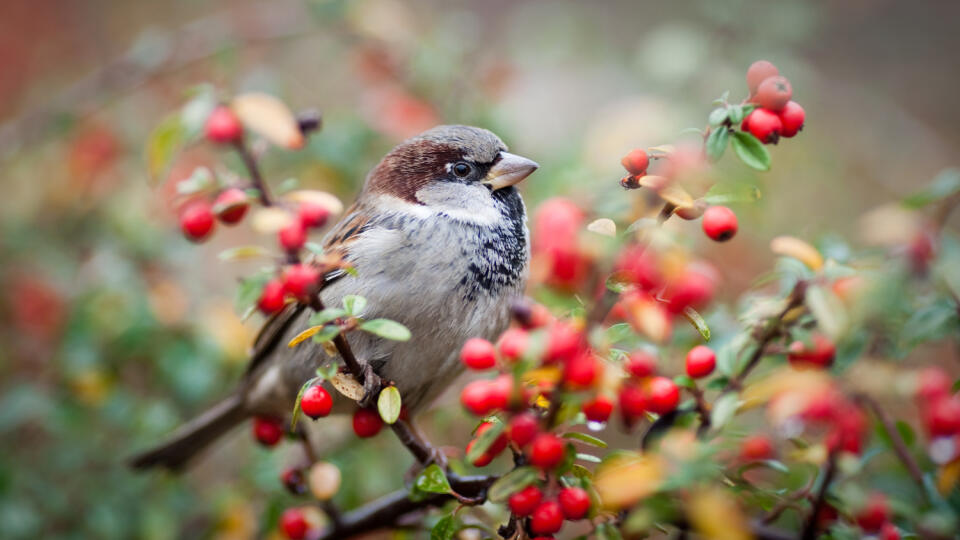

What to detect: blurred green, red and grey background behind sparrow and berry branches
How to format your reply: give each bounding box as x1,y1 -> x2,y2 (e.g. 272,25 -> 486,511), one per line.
0,0 -> 960,539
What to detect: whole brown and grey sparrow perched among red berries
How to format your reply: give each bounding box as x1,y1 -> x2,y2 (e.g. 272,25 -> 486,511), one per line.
131,125 -> 538,470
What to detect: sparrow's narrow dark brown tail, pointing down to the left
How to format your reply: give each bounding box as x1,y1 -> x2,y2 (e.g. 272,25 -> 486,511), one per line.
130,394 -> 248,471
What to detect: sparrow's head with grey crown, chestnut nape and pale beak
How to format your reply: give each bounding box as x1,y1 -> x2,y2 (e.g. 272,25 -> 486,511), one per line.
365,126 -> 538,219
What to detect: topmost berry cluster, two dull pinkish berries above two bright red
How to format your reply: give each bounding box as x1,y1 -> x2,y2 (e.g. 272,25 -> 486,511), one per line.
740,60 -> 804,144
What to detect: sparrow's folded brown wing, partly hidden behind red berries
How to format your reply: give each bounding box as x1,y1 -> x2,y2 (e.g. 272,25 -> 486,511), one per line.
247,203 -> 370,374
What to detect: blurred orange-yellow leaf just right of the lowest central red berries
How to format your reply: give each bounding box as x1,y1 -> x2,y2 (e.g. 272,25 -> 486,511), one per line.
594,454 -> 666,510
